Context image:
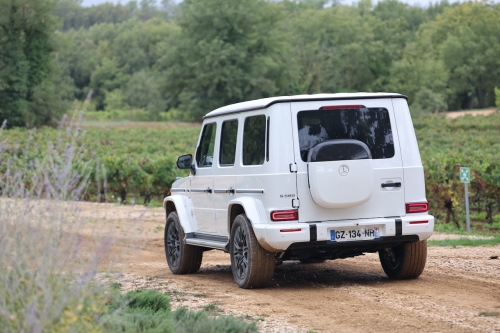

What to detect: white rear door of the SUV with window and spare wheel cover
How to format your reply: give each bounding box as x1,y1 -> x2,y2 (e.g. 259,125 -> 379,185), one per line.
291,99 -> 405,222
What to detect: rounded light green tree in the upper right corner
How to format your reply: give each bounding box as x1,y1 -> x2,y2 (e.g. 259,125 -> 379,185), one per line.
391,2 -> 500,110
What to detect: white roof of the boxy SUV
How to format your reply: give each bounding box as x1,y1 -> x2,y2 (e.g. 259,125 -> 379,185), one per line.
203,93 -> 408,118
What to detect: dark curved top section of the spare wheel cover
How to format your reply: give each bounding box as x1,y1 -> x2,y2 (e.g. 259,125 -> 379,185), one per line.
308,141 -> 370,162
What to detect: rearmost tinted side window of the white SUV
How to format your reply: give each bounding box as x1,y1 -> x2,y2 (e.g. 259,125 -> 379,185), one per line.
243,115 -> 266,165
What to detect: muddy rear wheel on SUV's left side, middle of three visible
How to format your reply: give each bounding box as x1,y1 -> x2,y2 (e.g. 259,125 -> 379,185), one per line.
230,214 -> 274,289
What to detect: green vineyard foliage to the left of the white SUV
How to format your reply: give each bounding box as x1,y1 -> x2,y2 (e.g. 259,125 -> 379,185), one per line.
0,123 -> 199,204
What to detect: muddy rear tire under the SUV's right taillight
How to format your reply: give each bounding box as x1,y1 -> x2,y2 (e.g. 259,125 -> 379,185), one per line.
378,240 -> 427,280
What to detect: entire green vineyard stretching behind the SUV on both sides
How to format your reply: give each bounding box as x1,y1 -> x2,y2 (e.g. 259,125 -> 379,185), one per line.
0,115 -> 500,225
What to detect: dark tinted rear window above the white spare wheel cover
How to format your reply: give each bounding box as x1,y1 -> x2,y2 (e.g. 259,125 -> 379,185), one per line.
297,107 -> 394,162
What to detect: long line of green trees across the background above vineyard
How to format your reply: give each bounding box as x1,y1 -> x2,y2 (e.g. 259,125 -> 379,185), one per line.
0,0 -> 500,127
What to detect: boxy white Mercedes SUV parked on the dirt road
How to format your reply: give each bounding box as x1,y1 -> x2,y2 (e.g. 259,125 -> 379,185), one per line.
164,93 -> 434,288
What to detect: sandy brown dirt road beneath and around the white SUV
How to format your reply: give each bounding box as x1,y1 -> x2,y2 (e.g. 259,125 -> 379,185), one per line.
84,204 -> 500,332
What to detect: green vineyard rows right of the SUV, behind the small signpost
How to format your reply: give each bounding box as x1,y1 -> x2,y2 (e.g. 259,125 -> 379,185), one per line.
414,115 -> 500,225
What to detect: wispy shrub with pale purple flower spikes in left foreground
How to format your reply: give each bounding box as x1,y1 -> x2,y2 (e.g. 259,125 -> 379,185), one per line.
0,108 -> 110,332
